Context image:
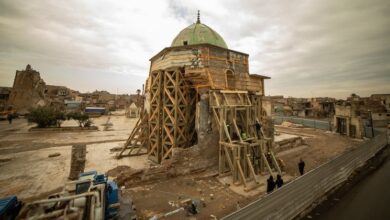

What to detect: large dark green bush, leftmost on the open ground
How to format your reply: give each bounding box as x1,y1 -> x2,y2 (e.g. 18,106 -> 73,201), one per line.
27,107 -> 65,128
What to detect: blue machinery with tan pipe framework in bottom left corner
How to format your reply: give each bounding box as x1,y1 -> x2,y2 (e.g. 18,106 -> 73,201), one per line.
0,171 -> 120,220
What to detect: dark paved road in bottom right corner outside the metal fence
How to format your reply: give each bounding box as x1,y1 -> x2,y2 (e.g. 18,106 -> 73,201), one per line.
315,150 -> 390,220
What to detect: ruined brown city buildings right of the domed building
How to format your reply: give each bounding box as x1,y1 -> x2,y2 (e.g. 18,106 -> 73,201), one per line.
262,94 -> 390,138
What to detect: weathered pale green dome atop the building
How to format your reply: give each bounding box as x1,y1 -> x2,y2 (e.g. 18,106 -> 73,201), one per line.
171,18 -> 227,49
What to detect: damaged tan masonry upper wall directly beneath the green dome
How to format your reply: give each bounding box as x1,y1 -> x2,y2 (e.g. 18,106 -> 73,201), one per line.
146,44 -> 268,94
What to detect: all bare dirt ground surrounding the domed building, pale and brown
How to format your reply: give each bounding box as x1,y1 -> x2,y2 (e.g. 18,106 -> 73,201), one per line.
0,114 -> 361,219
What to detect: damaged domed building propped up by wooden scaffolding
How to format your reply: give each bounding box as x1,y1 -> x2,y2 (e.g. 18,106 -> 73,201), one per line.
119,14 -> 281,191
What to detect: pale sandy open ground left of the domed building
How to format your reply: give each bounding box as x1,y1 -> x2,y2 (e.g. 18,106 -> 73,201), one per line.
0,113 -> 145,200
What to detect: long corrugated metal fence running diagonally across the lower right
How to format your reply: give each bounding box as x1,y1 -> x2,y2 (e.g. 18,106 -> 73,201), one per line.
223,131 -> 388,220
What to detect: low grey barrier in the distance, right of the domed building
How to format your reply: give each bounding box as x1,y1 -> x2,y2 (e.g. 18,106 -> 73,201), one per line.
272,115 -> 332,131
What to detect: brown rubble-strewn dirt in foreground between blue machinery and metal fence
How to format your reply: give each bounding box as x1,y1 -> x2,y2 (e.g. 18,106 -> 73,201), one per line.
125,175 -> 250,219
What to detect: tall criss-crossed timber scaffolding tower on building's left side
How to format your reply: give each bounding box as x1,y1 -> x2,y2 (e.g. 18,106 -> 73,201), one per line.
120,68 -> 197,163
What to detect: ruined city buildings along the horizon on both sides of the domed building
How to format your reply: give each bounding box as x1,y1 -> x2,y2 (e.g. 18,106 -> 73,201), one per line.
0,65 -> 390,138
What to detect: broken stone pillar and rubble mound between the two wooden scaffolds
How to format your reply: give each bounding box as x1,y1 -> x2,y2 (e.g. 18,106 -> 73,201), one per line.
115,93 -> 219,187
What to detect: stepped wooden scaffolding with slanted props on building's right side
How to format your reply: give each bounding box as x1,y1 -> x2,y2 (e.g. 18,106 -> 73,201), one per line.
210,90 -> 281,190
